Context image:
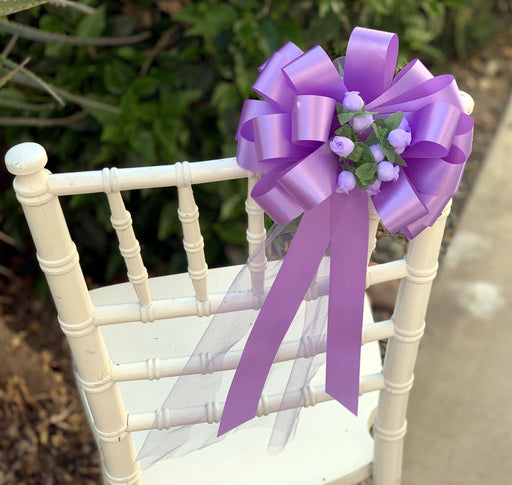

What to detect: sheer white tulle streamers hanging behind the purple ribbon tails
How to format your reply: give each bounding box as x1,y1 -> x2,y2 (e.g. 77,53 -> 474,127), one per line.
138,221 -> 329,468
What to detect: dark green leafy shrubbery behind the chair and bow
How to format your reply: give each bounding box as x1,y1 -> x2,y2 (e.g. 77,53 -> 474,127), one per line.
0,0 -> 510,279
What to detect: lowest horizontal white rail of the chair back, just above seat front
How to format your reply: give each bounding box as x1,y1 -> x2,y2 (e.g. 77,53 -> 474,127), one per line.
127,372 -> 385,432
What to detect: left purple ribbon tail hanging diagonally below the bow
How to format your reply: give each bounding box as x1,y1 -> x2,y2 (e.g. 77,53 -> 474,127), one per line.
218,199 -> 331,436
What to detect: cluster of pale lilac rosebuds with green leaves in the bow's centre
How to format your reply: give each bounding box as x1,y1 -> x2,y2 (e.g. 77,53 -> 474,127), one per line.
330,91 -> 411,195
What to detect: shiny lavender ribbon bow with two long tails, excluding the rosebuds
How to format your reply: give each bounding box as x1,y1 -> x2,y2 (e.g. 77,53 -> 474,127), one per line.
219,27 -> 473,435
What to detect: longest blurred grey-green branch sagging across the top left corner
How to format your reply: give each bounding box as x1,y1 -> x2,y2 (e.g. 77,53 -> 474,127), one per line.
0,19 -> 151,46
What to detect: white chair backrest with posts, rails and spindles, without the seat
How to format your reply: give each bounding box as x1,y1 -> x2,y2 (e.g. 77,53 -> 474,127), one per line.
6,143 -> 449,483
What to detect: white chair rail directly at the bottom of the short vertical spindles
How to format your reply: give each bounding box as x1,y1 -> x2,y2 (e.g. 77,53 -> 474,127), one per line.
94,260 -> 408,326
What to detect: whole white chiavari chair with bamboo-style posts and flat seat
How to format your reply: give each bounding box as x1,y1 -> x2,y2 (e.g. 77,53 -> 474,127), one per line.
6,87 -> 470,485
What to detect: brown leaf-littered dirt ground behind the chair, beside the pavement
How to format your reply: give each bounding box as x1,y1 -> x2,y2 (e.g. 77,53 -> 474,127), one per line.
0,22 -> 512,485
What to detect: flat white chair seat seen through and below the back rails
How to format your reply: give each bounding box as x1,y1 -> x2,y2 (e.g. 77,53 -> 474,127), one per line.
90,266 -> 382,485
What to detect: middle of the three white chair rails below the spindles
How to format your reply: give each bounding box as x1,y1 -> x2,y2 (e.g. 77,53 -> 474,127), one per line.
112,320 -> 395,382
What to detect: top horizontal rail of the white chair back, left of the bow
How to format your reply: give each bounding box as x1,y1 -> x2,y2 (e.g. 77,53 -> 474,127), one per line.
47,157 -> 251,196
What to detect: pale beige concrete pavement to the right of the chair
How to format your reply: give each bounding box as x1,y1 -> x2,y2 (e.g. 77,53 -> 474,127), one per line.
403,91 -> 512,485
